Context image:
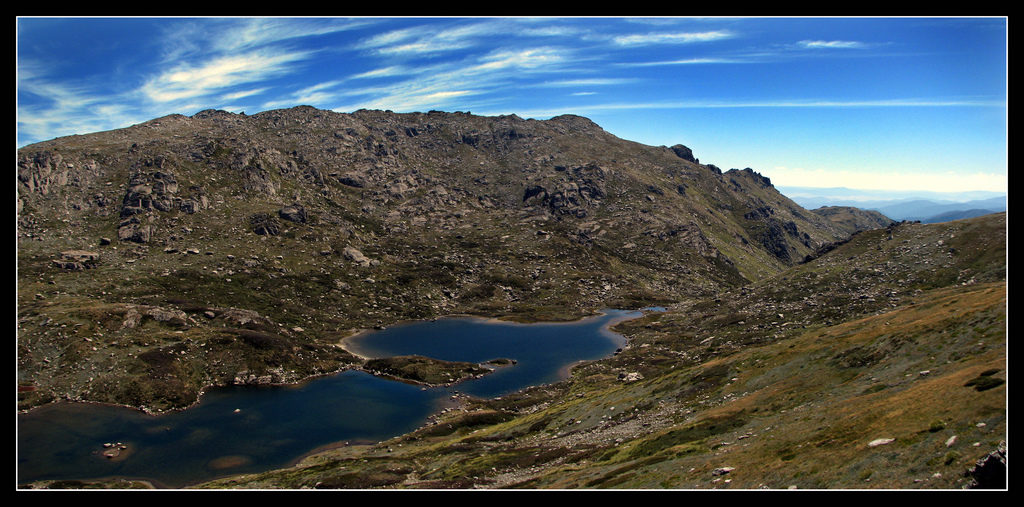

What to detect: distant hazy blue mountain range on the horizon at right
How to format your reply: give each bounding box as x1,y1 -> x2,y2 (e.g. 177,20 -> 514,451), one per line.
777,186 -> 1007,223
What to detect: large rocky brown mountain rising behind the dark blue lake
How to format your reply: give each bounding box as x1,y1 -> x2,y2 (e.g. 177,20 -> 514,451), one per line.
17,107 -> 848,411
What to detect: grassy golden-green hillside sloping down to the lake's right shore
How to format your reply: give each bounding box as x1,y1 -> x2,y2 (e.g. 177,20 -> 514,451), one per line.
188,215 -> 1008,489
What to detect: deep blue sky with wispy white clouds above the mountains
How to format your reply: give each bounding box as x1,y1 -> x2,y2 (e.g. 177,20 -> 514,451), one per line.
16,16 -> 1008,192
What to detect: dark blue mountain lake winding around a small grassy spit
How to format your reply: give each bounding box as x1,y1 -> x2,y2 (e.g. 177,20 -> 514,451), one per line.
17,310 -> 641,488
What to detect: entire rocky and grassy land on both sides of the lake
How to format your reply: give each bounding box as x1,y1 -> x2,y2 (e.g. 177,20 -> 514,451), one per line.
17,107 -> 1007,489
